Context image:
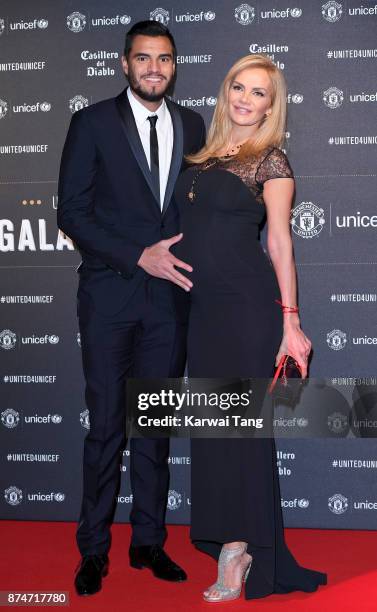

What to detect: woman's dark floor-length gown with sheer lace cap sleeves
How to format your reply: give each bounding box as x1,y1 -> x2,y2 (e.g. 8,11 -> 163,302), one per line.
174,147 -> 326,599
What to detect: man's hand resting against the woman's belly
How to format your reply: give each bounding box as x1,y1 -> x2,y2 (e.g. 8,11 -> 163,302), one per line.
137,234 -> 192,291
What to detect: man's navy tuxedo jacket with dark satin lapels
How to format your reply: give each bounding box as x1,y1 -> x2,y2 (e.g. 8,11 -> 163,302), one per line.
58,89 -> 205,315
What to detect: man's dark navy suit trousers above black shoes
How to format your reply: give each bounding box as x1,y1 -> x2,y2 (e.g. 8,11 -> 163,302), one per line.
76,277 -> 186,555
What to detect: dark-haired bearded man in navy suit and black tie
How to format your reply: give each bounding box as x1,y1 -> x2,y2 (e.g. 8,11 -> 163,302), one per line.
58,21 -> 205,595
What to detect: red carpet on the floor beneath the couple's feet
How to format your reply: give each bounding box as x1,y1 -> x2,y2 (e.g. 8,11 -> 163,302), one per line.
0,521 -> 377,612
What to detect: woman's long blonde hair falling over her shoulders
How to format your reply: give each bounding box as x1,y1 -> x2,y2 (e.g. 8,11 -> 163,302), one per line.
186,53 -> 287,164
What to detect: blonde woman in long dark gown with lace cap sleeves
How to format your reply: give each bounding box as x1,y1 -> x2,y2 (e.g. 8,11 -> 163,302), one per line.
175,55 -> 326,602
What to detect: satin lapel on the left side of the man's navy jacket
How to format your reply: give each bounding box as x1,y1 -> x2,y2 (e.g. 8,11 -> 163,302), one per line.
115,89 -> 160,210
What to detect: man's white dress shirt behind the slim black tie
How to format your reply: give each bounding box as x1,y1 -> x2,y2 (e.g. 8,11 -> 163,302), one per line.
127,87 -> 174,210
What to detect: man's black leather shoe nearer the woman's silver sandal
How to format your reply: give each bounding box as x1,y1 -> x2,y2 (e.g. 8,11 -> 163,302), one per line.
129,544 -> 187,582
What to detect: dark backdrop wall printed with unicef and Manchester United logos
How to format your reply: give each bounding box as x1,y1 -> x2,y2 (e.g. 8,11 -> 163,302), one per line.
0,0 -> 377,529
